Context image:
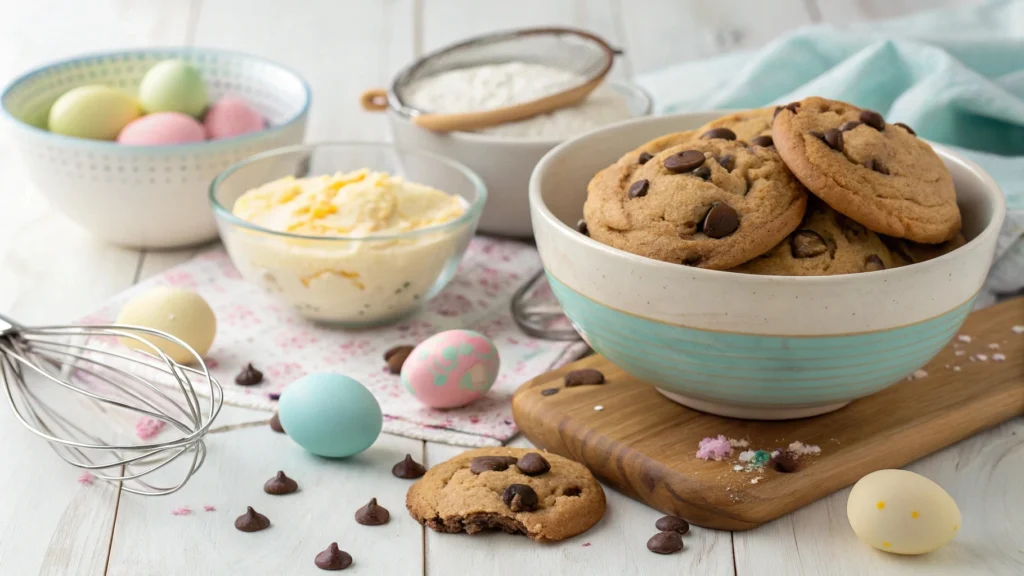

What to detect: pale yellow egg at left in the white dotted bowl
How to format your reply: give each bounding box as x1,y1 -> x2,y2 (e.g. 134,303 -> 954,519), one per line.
49,85 -> 141,140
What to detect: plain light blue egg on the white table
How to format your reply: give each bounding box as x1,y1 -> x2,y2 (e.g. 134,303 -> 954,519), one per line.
278,373 -> 384,458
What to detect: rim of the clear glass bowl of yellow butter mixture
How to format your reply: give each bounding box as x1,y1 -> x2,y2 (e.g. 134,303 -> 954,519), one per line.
208,140 -> 487,242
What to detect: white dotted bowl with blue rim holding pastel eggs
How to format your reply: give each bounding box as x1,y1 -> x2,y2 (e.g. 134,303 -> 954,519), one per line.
0,48 -> 310,248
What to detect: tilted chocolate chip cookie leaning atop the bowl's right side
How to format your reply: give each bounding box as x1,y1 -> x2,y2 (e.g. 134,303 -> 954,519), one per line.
772,97 -> 961,244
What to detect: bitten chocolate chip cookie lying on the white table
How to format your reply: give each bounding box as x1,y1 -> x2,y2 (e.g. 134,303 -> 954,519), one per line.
406,448 -> 604,541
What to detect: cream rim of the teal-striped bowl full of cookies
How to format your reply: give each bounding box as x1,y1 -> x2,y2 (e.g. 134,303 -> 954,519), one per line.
529,110 -> 1007,286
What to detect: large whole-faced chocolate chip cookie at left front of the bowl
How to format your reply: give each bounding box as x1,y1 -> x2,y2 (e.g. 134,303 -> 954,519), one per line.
584,134 -> 807,270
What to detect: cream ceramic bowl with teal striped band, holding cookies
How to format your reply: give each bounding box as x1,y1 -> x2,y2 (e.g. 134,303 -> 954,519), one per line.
529,112 -> 1006,419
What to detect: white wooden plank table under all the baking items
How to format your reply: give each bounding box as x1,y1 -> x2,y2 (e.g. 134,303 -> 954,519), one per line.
0,0 -> 1024,576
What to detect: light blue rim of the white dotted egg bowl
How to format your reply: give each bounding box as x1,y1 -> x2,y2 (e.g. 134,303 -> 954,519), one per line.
0,46 -> 312,154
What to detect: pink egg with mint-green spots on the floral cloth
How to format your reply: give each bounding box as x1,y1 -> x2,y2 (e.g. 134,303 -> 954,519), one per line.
401,330 -> 501,408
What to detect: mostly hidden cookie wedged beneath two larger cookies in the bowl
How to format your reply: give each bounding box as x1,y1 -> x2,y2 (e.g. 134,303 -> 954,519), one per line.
732,198 -> 903,276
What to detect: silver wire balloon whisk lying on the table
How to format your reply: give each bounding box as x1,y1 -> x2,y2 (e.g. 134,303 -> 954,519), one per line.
0,315 -> 224,495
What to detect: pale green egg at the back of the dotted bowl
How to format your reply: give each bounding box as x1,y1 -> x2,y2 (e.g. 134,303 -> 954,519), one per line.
138,59 -> 207,118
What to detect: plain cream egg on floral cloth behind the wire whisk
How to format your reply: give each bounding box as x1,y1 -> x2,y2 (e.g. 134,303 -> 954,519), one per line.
118,287 -> 217,364
